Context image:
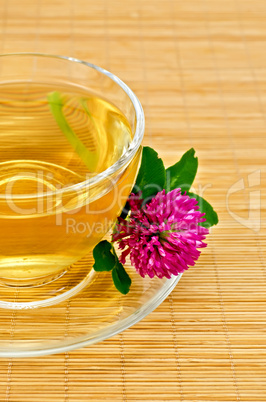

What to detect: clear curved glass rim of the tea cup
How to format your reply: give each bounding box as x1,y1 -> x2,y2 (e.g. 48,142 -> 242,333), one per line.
0,52 -> 145,199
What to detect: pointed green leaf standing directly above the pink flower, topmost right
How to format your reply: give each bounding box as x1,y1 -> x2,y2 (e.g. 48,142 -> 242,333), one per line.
166,148 -> 198,193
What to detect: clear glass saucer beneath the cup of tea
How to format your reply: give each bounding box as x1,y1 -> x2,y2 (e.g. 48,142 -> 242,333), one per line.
0,256 -> 182,357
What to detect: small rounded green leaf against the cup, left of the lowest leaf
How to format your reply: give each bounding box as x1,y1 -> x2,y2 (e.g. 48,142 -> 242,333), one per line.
93,240 -> 117,272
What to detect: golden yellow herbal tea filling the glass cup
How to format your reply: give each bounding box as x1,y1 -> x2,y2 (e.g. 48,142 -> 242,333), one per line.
0,82 -> 140,285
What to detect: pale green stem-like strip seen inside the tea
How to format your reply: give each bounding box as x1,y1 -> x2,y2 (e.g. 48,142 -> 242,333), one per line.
47,91 -> 99,172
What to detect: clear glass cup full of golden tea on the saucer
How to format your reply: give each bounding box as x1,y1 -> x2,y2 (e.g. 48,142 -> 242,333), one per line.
0,53 -> 144,309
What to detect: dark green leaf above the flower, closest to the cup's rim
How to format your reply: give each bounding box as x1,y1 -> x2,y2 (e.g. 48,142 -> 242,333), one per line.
132,147 -> 165,199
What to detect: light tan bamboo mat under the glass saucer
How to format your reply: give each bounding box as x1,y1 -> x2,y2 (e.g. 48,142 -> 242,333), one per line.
0,0 -> 266,402
